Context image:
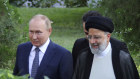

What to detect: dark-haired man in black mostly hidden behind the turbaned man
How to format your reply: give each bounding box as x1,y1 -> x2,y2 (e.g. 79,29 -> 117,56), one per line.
72,11 -> 128,68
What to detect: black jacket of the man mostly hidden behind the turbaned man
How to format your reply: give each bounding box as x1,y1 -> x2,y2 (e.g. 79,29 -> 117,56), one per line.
72,38 -> 128,68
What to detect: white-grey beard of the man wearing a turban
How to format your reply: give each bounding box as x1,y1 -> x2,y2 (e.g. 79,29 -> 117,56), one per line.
89,38 -> 107,55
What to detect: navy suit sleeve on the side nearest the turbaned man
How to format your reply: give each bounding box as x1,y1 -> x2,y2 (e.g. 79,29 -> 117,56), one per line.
59,52 -> 73,79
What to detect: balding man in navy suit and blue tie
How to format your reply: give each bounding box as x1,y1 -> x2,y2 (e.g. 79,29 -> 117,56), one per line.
13,14 -> 73,79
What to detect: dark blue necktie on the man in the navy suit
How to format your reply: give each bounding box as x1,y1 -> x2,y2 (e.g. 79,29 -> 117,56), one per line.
31,48 -> 40,78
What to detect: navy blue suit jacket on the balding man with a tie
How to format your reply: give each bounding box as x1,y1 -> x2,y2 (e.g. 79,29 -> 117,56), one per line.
13,41 -> 73,79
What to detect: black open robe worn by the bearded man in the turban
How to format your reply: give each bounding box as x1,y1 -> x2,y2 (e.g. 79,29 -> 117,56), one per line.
72,41 -> 139,79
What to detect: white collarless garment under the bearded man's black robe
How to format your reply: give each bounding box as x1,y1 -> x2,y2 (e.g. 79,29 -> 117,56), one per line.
89,43 -> 116,79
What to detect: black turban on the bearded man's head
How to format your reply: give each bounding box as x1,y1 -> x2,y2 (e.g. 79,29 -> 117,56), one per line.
85,16 -> 114,33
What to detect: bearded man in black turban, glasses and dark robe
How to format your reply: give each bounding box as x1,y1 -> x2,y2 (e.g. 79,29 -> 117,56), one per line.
73,16 -> 139,79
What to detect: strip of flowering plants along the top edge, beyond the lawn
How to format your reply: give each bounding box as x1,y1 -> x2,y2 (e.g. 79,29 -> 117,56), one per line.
9,0 -> 88,8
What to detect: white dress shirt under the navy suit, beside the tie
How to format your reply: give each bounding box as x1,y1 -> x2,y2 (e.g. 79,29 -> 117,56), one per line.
29,38 -> 50,75
